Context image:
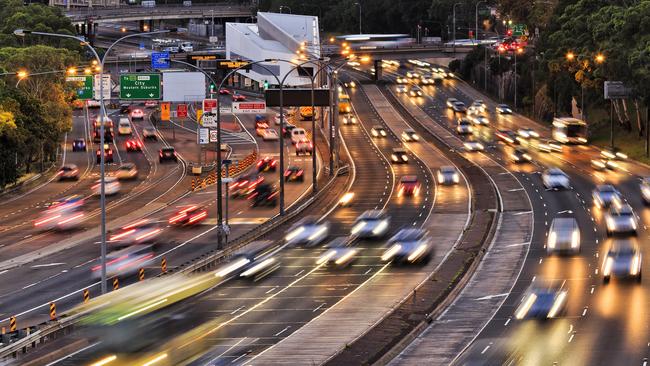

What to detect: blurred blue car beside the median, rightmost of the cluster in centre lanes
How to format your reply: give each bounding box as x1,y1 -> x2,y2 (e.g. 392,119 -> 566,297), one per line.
381,229 -> 432,264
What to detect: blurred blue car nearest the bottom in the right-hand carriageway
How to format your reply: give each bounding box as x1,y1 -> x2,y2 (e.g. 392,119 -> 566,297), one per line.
515,279 -> 568,320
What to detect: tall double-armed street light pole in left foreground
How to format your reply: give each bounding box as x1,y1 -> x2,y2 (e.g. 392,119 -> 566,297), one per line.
14,29 -> 175,294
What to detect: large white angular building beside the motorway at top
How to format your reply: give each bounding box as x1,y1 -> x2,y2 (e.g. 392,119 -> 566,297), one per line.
226,12 -> 321,88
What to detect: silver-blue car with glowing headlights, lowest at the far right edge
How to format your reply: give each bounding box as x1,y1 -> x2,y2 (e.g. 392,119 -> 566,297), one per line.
602,240 -> 643,284
